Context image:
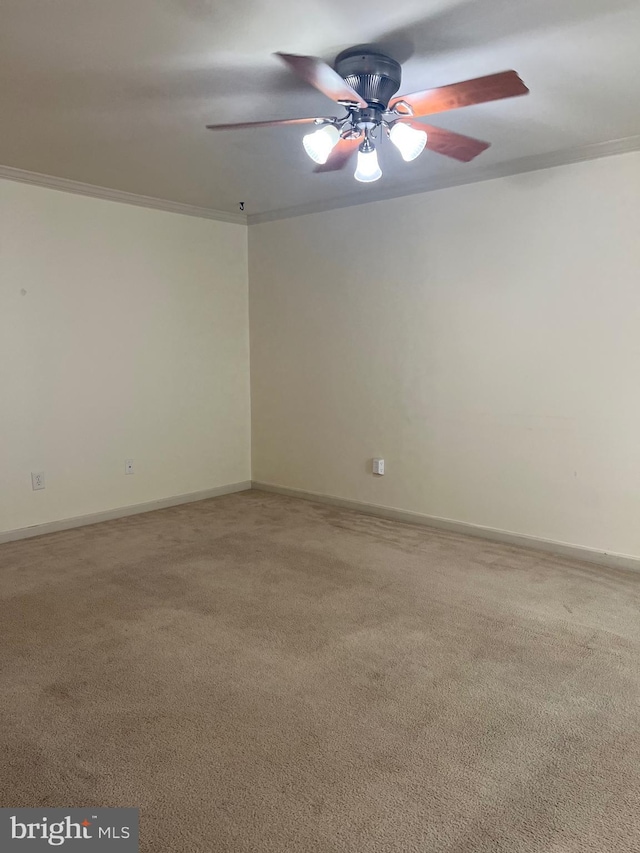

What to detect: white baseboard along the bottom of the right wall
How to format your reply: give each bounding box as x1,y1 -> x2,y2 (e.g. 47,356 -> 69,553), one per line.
251,480 -> 640,571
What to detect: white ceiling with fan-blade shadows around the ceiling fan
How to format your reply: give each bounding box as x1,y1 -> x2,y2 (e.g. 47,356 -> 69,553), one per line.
0,0 -> 640,220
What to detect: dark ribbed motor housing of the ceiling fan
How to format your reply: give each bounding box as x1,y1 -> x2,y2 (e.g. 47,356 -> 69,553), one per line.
335,47 -> 402,110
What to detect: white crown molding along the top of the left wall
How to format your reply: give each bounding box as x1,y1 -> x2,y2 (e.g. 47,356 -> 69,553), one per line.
0,166 -> 247,225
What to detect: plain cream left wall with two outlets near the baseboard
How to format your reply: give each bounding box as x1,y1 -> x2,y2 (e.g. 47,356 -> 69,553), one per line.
0,181 -> 251,531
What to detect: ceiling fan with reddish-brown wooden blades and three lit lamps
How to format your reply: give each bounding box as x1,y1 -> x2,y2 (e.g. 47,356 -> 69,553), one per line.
207,45 -> 529,183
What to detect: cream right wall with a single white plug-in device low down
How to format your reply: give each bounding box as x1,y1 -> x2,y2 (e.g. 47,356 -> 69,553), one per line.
249,153 -> 640,556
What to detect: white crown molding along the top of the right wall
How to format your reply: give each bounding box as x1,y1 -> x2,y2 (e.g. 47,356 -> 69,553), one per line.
247,135 -> 640,225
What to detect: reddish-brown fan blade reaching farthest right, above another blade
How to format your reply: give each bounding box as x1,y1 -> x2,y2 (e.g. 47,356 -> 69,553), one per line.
389,71 -> 529,116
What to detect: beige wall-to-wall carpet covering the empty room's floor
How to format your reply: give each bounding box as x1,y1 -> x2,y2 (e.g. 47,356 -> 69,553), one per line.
0,492 -> 640,853
